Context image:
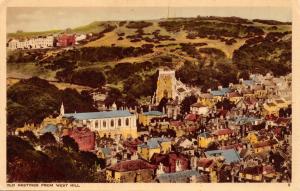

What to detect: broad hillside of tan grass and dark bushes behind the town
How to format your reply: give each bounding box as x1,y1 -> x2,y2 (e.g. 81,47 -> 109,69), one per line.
7,17 -> 291,97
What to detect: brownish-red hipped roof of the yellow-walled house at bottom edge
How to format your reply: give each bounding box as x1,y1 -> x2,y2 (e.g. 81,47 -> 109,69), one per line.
107,159 -> 156,172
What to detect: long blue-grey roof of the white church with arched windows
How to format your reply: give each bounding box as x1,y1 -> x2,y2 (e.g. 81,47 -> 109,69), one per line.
64,110 -> 133,120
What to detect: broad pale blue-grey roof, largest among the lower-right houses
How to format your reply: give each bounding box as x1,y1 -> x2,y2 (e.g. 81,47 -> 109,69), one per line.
205,149 -> 240,164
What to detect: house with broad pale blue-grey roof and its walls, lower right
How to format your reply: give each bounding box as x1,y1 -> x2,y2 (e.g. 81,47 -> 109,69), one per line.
204,149 -> 240,164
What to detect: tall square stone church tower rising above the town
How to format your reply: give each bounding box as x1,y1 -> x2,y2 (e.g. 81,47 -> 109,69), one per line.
155,69 -> 176,104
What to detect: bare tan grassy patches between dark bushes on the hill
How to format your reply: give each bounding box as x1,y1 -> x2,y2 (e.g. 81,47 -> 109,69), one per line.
7,17 -> 291,91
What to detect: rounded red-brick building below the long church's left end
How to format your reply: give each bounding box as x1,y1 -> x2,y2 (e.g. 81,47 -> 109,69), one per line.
63,127 -> 96,151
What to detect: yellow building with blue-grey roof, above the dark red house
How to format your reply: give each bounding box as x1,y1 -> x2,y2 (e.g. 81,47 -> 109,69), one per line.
137,137 -> 171,161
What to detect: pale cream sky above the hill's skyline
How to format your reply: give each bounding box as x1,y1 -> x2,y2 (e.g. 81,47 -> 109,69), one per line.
7,7 -> 292,32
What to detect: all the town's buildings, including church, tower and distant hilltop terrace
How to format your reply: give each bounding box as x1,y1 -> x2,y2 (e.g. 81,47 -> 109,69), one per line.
9,68 -> 292,183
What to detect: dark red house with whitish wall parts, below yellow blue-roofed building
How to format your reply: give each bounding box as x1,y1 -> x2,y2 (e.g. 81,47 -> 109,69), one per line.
150,152 -> 189,174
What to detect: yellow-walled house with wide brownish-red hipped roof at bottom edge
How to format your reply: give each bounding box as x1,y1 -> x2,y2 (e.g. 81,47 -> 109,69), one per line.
105,159 -> 156,183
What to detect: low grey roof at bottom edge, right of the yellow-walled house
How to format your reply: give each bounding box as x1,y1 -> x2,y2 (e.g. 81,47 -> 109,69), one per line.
157,170 -> 200,183
